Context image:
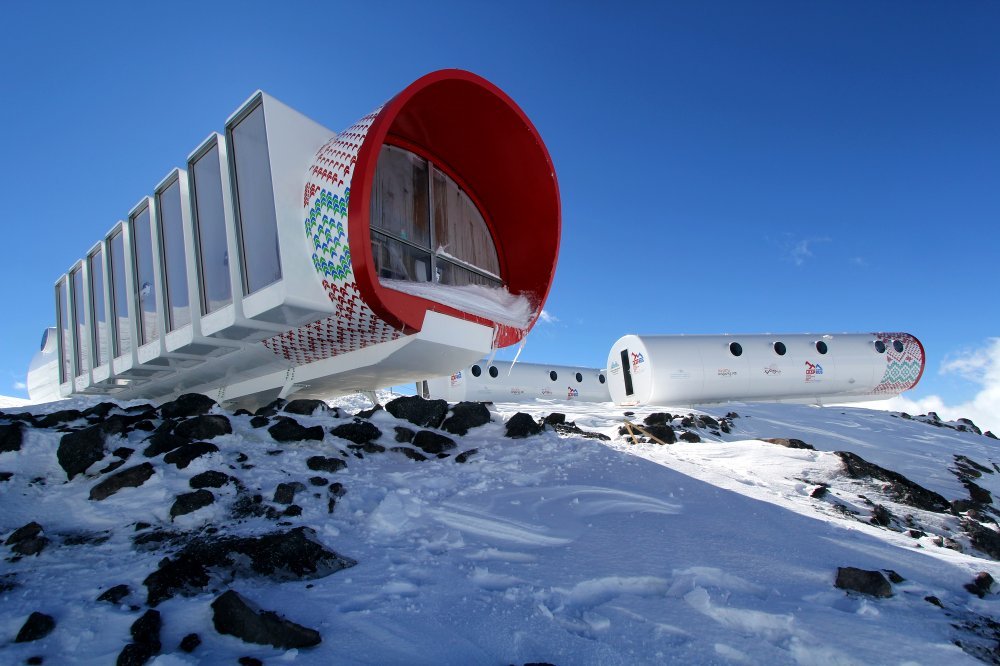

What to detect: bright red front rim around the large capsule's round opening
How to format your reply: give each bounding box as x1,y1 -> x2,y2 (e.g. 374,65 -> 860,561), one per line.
348,69 -> 562,346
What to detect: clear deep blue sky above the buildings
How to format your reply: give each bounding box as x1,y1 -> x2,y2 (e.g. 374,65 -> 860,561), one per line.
0,2 -> 1000,422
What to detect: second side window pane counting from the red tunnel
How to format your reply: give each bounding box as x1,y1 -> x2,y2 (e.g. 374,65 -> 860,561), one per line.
191,146 -> 233,314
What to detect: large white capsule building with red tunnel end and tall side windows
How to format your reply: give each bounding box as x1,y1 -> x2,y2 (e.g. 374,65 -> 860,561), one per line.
28,70 -> 561,405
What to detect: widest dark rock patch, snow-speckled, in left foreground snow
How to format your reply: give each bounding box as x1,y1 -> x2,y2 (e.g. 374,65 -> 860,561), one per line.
143,527 -> 357,606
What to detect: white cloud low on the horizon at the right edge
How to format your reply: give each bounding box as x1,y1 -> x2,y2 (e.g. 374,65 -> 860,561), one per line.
858,338 -> 1000,435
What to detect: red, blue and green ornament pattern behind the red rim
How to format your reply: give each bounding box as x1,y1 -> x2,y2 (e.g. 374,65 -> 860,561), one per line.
264,107 -> 402,365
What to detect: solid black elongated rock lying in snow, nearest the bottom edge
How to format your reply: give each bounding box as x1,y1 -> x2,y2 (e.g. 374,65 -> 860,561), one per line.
212,590 -> 322,650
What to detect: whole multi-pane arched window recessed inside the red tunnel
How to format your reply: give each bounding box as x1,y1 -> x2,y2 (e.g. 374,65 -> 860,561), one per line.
370,145 -> 503,287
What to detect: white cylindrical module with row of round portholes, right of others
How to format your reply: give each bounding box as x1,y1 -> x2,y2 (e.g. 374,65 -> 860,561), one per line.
608,333 -> 926,405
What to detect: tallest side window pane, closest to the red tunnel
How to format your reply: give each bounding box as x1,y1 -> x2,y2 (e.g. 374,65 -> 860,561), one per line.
232,105 -> 281,294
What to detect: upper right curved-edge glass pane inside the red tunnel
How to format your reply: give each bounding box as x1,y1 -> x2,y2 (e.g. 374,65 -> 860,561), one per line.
434,169 -> 500,278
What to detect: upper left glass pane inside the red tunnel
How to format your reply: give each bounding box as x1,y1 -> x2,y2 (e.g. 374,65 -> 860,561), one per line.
371,146 -> 431,248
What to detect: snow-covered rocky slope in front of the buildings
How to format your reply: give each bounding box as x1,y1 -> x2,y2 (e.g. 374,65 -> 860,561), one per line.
0,398 -> 1000,665
